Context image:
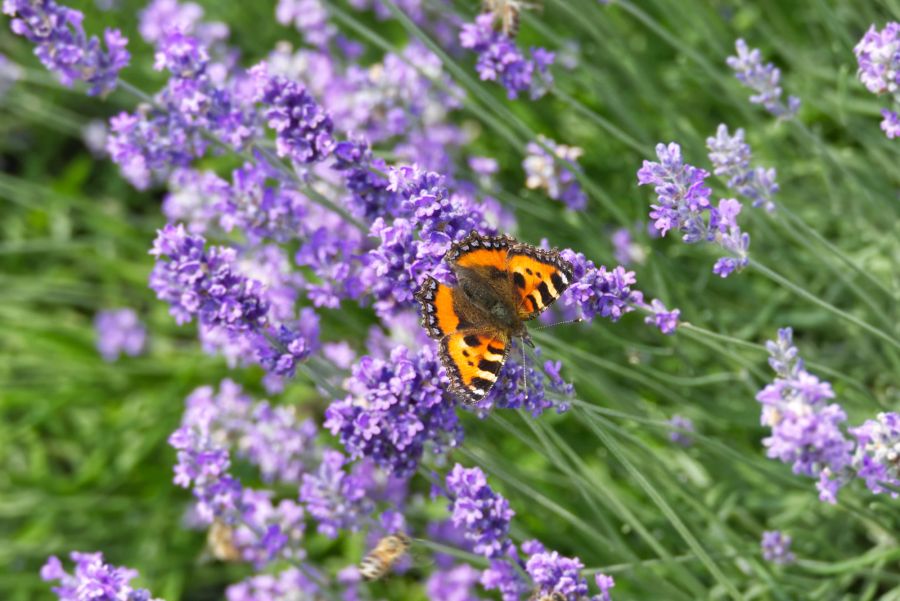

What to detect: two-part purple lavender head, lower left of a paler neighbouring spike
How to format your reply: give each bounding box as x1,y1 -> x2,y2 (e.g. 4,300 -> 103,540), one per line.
638,142 -> 750,278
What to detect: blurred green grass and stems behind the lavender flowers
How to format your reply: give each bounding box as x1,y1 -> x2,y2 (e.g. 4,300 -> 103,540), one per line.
0,0 -> 900,601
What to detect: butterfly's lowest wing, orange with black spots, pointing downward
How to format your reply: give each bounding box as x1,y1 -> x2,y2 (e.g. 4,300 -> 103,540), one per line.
441,329 -> 510,404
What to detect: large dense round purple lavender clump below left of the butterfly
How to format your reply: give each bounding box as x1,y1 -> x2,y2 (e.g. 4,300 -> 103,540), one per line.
325,345 -> 463,477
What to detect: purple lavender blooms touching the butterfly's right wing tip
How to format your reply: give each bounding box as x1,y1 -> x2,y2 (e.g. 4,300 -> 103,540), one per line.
559,248 -> 644,322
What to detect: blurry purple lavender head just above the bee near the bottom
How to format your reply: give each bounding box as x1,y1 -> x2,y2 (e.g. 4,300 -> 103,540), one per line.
300,450 -> 375,538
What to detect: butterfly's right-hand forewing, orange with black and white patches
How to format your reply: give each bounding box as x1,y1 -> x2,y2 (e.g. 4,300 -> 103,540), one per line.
507,244 -> 572,320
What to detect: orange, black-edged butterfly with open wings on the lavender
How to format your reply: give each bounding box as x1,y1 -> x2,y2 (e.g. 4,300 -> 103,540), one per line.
415,232 -> 572,404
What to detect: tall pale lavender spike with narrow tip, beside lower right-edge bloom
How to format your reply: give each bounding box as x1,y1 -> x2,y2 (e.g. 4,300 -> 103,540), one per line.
756,328 -> 853,503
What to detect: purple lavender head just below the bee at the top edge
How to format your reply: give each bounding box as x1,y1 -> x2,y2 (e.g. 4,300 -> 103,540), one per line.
459,14 -> 554,99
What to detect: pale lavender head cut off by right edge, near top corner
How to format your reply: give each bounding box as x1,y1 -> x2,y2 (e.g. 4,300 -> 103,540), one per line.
853,21 -> 900,139
